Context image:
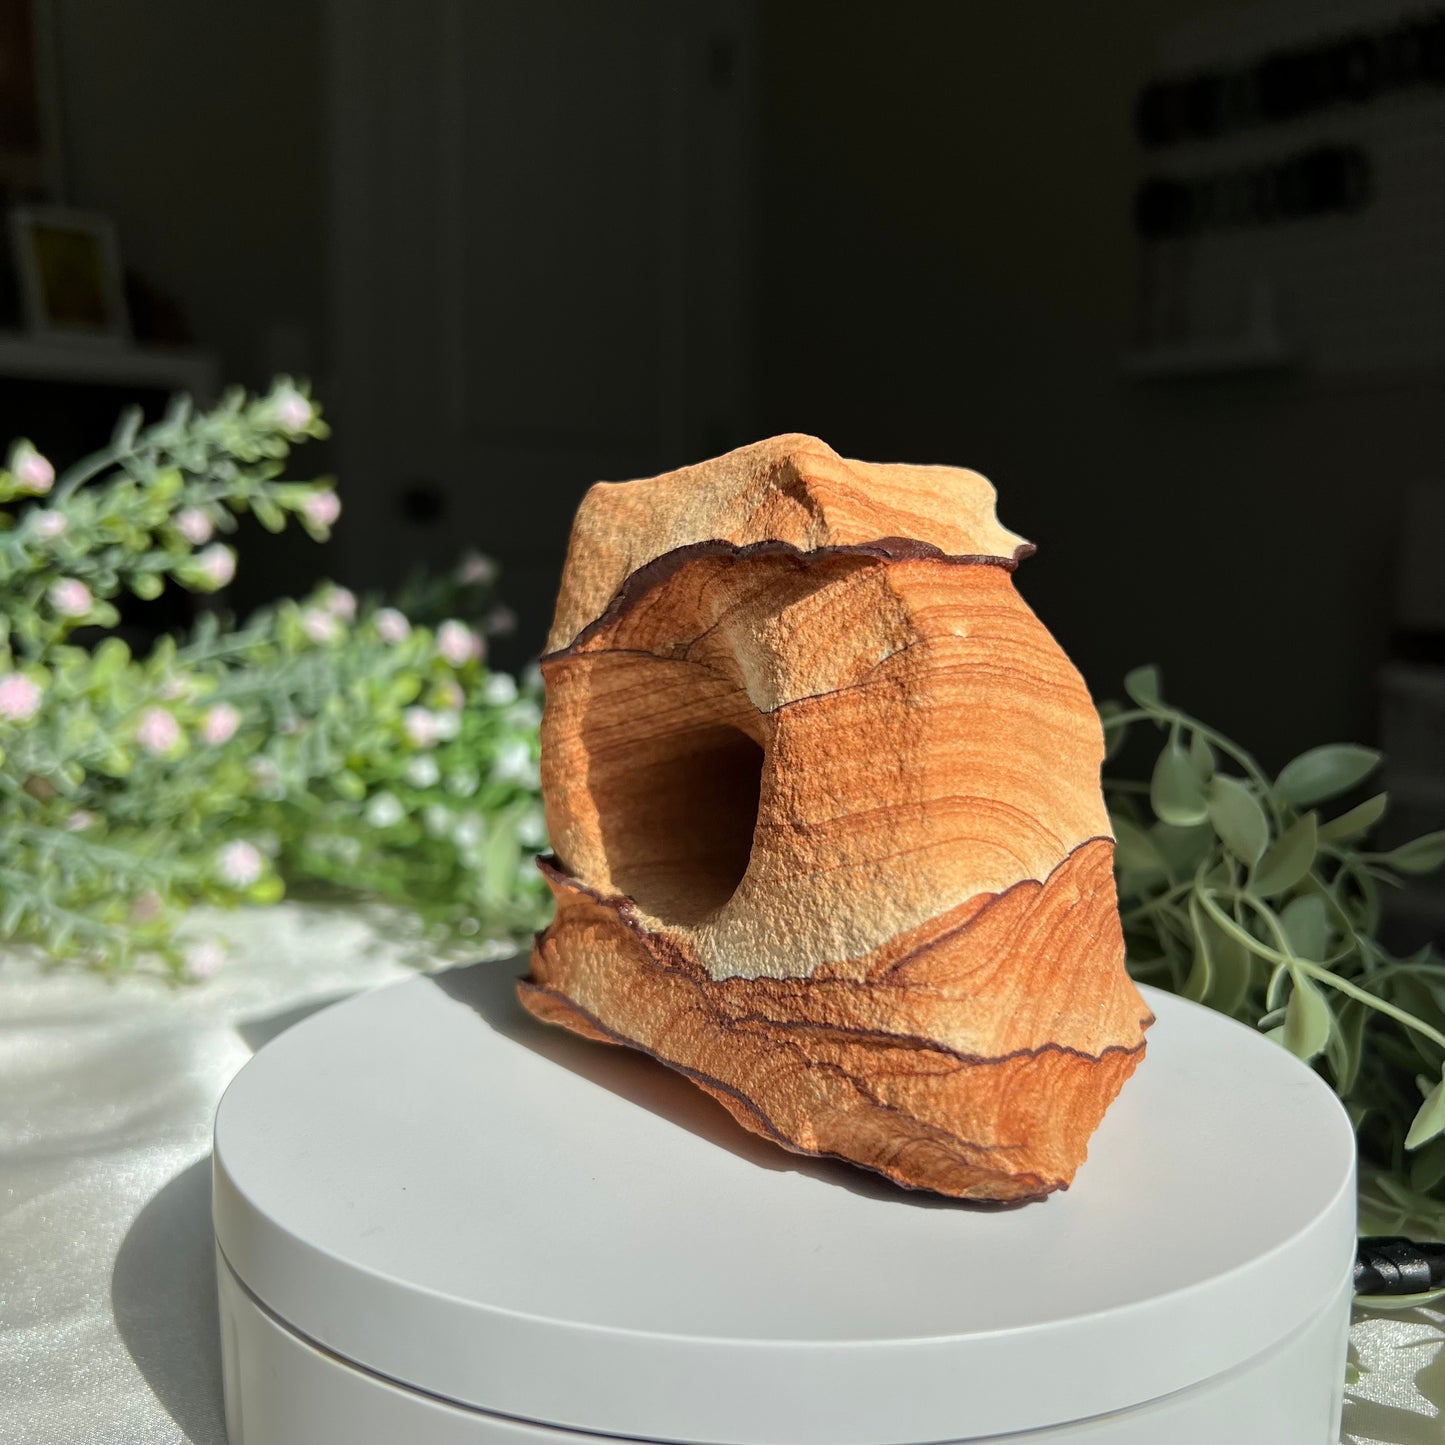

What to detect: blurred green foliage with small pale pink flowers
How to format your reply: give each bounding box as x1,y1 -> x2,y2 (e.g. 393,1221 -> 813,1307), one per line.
0,379 -> 546,977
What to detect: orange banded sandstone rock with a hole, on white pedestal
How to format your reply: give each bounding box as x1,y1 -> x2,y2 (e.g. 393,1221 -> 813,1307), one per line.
519,436 -> 1152,1201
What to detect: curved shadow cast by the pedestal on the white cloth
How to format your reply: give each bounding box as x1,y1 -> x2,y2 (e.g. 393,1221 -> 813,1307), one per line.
110,1155 -> 225,1445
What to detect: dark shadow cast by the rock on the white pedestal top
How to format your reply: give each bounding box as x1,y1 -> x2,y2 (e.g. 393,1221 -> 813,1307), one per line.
431,958 -> 1028,1212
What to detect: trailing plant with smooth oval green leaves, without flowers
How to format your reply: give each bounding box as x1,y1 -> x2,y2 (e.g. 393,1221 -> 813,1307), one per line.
1100,668 -> 1445,1238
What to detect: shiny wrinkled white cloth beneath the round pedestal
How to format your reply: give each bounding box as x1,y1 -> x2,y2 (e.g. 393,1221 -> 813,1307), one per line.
0,903 -> 1445,1445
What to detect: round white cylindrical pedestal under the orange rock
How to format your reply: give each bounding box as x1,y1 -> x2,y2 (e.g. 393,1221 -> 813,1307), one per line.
215,962 -> 1354,1445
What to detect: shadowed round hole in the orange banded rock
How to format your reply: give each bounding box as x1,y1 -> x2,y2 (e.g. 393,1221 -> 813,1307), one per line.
588,665 -> 764,925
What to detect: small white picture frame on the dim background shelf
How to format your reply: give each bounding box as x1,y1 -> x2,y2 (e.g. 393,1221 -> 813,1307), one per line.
10,205 -> 130,345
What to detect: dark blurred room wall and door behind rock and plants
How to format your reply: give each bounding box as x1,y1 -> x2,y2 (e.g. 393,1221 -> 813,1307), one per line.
0,0 -> 1445,930
